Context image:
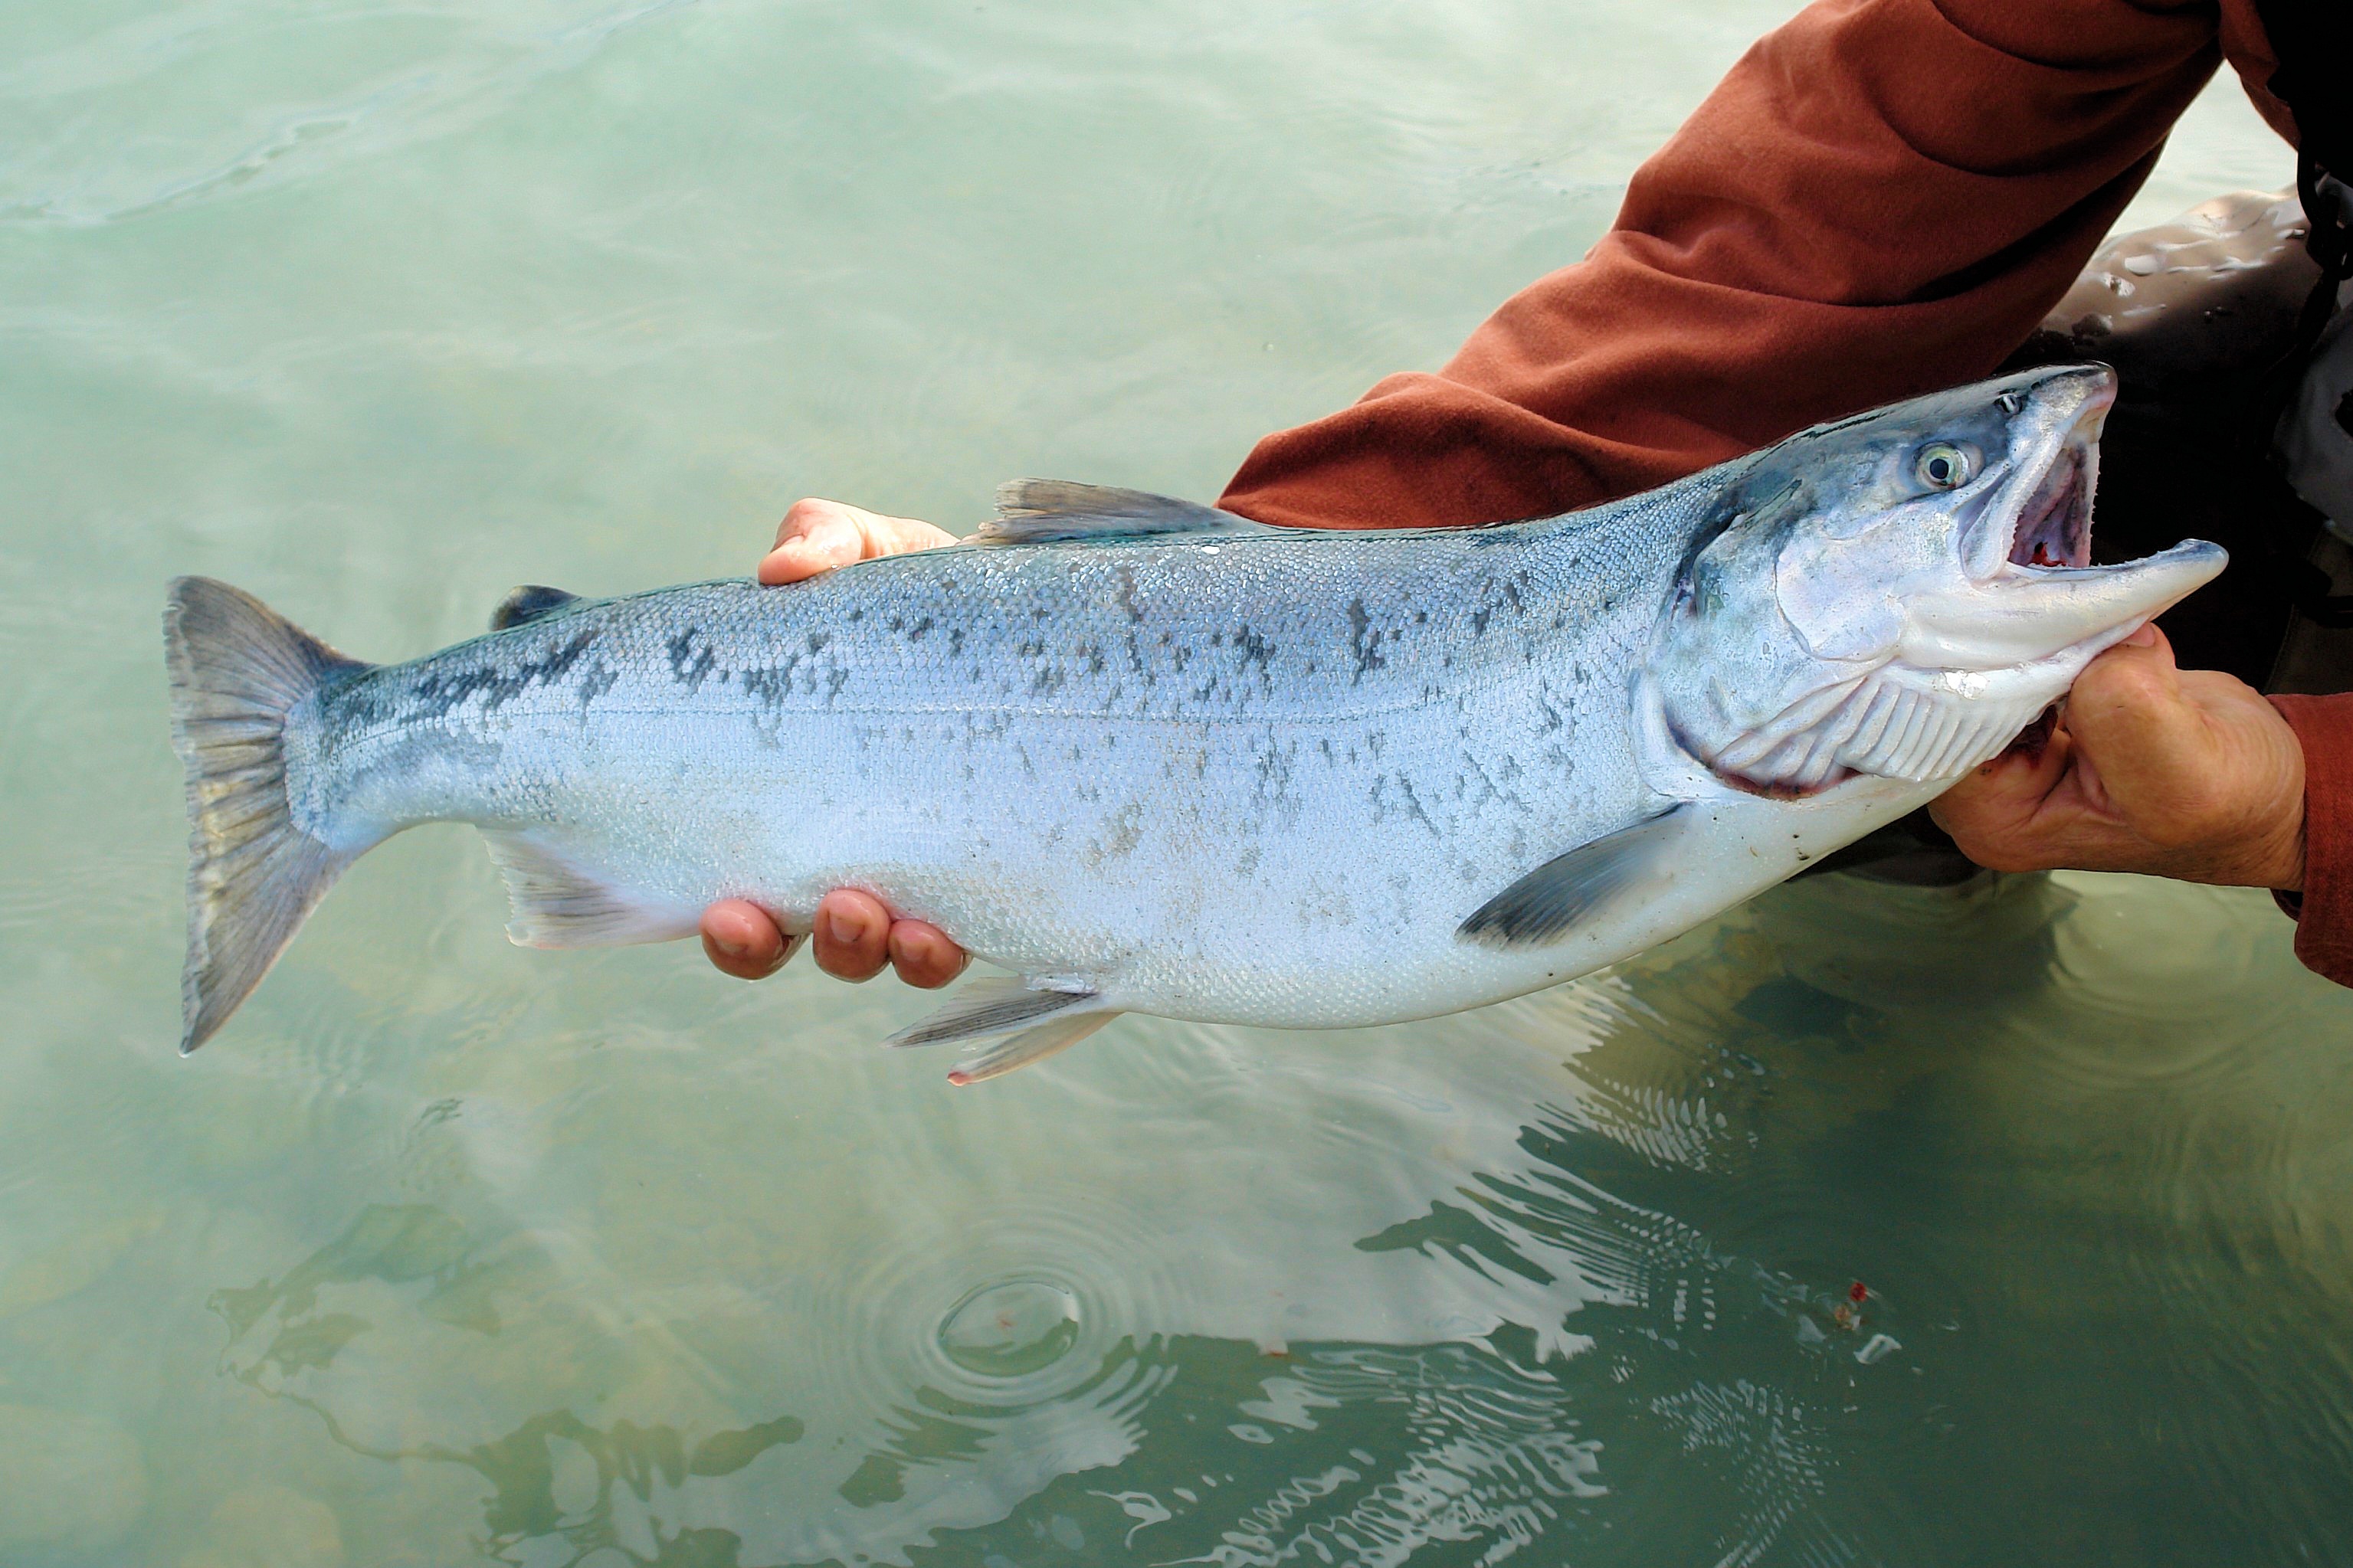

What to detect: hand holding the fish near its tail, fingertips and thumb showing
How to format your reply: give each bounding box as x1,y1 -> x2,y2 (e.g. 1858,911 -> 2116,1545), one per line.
703,499 -> 967,990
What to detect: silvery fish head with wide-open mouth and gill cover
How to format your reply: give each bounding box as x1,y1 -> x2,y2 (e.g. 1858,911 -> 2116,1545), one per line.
1645,365 -> 2228,794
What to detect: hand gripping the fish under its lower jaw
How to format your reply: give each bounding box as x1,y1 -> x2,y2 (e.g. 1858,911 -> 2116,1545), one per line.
1929,625 -> 2304,891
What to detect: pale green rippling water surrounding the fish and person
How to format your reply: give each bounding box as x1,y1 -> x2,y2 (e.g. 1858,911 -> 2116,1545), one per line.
0,0 -> 2353,1568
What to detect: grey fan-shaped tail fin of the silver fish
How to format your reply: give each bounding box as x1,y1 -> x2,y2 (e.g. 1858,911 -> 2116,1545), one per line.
162,576 -> 367,1053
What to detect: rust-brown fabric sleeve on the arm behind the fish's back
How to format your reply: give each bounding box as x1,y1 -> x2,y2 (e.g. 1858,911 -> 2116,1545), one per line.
1224,0 -> 2285,526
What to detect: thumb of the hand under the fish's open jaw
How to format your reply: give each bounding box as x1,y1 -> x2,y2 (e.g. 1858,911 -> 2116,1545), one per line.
2066,627 -> 2217,837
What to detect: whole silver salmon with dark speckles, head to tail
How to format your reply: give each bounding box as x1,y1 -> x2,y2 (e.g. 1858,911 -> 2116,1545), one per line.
172,372 -> 2219,1077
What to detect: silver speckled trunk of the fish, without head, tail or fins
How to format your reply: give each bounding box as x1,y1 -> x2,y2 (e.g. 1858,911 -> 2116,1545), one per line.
308,493 -> 1696,1027
